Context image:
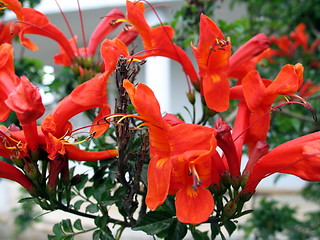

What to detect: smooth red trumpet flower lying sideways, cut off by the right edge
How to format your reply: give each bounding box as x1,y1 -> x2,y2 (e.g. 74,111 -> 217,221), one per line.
245,132 -> 320,192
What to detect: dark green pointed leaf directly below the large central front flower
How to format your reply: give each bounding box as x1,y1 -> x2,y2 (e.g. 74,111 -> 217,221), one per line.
132,211 -> 174,235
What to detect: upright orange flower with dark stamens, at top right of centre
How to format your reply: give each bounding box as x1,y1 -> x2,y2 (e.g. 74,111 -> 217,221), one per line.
193,14 -> 231,112
